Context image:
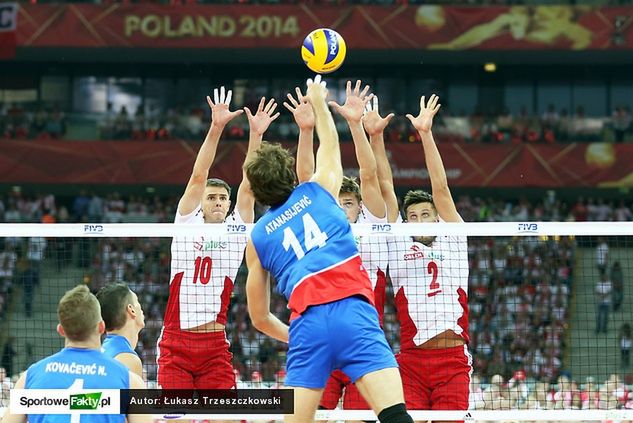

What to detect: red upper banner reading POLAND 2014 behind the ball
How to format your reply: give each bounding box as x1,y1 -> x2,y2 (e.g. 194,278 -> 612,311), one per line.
11,3 -> 633,50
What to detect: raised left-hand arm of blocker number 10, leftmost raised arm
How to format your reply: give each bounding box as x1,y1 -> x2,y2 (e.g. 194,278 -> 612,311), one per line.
178,87 -> 242,216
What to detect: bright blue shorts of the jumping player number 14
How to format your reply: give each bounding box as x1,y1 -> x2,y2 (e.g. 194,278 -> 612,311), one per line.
285,297 -> 398,388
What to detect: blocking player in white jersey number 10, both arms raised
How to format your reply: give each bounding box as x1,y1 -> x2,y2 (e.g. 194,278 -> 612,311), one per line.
157,87 -> 279,389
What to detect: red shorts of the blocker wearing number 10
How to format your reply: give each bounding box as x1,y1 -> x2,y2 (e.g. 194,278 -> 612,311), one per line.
157,330 -> 235,389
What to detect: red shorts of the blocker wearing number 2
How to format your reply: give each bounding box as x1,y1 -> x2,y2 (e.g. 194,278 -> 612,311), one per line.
396,345 -> 472,410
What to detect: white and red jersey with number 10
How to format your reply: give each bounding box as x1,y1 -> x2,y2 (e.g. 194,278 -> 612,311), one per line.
165,206 -> 248,329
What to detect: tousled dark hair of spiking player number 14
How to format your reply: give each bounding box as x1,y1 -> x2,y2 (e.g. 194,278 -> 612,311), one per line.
244,142 -> 297,206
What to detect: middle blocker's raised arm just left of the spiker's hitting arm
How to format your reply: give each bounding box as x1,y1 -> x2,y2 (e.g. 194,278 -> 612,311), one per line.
284,87 -> 315,183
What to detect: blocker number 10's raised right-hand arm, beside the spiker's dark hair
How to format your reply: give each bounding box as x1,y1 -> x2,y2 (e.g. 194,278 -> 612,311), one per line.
235,97 -> 279,223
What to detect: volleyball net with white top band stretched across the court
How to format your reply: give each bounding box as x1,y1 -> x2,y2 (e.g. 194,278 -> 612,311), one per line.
0,222 -> 633,421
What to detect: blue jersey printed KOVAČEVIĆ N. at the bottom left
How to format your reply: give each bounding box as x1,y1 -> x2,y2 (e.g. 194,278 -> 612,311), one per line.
25,348 -> 130,423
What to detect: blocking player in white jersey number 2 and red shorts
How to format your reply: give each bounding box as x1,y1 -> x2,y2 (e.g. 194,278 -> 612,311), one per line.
389,95 -> 472,416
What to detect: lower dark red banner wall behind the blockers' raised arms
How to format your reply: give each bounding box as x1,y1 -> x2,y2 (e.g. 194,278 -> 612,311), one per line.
0,140 -> 633,188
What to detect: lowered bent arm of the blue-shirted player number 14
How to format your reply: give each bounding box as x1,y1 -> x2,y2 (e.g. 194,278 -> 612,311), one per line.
246,240 -> 288,342
